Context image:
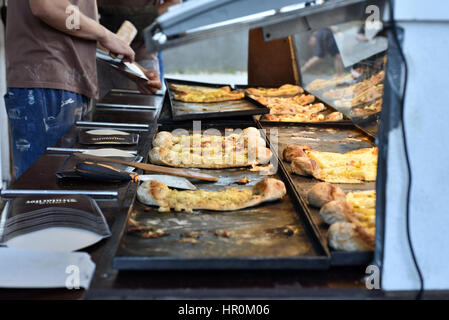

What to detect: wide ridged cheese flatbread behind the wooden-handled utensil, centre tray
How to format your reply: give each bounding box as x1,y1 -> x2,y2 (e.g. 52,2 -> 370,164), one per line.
149,127 -> 272,169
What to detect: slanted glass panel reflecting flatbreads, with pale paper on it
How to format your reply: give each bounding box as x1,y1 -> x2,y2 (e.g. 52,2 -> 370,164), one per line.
293,21 -> 388,136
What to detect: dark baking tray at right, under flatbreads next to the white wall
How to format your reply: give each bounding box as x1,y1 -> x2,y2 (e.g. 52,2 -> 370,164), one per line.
259,123 -> 376,266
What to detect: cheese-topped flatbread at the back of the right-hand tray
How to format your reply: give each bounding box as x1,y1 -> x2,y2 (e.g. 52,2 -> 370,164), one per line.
291,147 -> 378,183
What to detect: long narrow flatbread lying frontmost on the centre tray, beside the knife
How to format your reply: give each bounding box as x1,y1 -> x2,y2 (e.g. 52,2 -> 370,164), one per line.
137,178 -> 286,212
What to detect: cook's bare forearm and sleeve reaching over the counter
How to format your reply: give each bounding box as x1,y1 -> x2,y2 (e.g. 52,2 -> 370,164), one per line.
29,0 -> 135,62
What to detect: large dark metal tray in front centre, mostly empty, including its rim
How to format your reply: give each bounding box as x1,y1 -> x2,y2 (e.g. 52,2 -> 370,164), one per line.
113,125 -> 330,270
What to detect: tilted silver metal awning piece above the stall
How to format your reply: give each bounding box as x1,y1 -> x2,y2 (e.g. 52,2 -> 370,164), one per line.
144,0 -> 377,52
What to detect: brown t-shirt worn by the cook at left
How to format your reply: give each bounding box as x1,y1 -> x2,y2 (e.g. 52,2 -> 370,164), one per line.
6,0 -> 98,98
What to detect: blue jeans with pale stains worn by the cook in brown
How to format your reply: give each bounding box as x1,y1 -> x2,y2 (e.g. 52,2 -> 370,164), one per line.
5,88 -> 89,178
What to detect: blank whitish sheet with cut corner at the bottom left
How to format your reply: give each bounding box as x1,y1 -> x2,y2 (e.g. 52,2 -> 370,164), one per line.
0,248 -> 95,289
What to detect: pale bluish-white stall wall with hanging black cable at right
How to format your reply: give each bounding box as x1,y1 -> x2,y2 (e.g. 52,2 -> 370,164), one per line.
378,0 -> 449,290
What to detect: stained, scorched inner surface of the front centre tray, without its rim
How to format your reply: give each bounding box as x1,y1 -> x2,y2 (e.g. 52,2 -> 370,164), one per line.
115,170 -> 318,258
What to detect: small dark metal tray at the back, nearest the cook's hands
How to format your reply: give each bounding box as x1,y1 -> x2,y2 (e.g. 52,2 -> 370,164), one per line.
165,79 -> 270,121
